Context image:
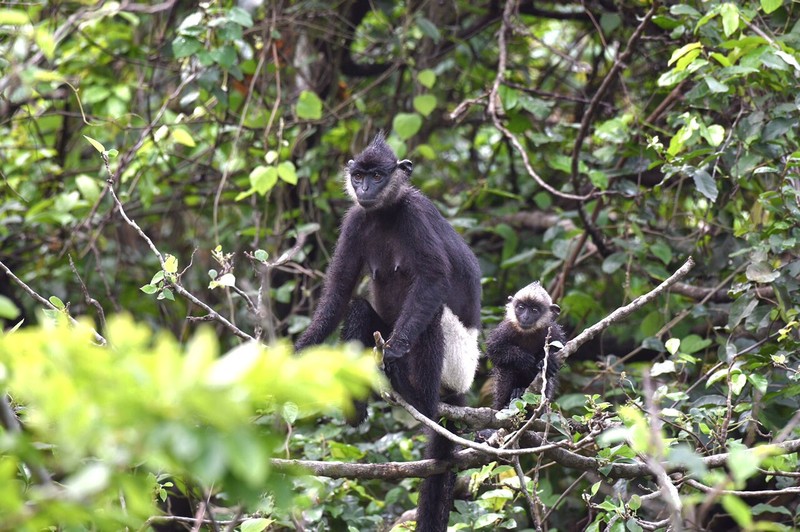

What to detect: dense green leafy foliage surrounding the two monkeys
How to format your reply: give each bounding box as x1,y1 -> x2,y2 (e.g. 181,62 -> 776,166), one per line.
0,0 -> 800,531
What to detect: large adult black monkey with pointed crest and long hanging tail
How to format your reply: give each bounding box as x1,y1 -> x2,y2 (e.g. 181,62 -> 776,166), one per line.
295,133 -> 481,532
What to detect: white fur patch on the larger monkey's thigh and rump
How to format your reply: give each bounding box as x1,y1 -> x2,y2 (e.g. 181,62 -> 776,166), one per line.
442,307 -> 481,393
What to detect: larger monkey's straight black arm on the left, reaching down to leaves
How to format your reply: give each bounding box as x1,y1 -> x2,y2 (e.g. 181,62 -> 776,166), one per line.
295,216 -> 363,350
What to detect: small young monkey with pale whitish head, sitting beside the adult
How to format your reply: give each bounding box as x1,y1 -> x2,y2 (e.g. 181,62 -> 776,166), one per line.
486,282 -> 565,410
